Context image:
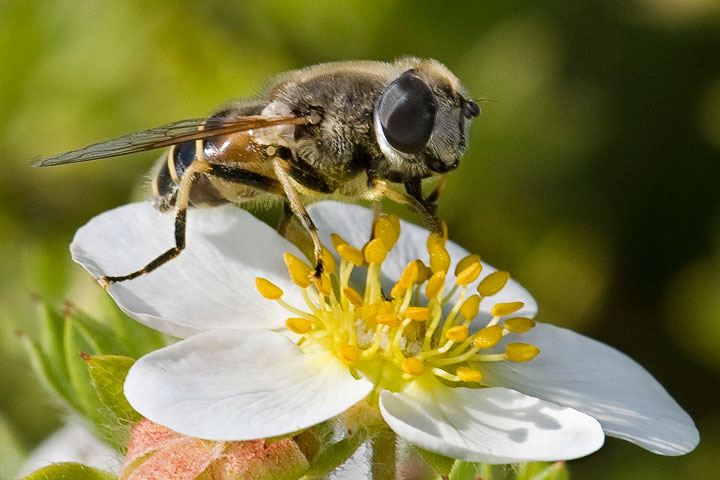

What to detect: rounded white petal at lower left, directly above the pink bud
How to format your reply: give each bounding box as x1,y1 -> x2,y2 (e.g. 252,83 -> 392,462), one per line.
125,330 -> 373,440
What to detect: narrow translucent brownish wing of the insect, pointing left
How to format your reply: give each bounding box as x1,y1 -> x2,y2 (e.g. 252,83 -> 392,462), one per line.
33,114 -> 308,167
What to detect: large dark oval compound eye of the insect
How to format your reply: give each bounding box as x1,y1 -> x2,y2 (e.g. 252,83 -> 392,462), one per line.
377,70 -> 437,154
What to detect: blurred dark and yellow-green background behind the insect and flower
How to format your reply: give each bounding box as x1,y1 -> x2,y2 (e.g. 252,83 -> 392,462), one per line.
0,0 -> 720,479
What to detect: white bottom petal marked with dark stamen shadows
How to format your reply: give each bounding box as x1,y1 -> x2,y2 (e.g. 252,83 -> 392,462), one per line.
380,383 -> 604,464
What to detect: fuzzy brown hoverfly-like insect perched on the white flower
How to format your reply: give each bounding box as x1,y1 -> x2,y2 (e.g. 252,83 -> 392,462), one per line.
35,58 -> 480,287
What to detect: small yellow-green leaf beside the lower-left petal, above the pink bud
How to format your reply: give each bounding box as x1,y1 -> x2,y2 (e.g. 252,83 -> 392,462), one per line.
85,355 -> 142,423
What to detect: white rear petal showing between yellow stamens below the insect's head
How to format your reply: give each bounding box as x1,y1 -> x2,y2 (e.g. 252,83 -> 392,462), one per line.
309,201 -> 537,322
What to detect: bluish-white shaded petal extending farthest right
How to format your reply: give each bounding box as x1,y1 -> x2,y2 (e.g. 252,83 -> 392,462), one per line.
483,323 -> 700,455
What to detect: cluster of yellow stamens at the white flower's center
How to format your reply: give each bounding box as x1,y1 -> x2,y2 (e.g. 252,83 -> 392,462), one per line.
256,215 -> 539,391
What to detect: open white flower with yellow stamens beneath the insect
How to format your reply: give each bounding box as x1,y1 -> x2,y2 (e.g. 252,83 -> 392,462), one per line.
71,202 -> 699,463
